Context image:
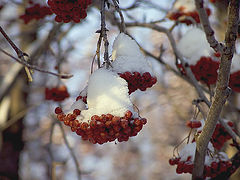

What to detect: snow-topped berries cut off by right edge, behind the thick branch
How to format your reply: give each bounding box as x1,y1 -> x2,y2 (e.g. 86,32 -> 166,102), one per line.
229,54 -> 240,93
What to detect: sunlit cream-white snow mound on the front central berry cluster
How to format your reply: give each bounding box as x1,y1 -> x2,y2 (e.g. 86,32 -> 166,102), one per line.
81,68 -> 133,121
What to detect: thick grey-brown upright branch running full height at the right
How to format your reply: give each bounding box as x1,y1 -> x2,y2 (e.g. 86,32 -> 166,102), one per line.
192,0 -> 239,179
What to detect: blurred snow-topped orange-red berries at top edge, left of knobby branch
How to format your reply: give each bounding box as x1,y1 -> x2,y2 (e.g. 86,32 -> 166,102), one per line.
168,0 -> 211,25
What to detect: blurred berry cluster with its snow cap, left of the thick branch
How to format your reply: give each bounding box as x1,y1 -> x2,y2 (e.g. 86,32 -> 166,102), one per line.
177,28 -> 221,86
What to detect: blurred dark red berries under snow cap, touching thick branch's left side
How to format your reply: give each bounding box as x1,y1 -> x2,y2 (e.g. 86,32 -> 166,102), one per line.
190,57 -> 219,86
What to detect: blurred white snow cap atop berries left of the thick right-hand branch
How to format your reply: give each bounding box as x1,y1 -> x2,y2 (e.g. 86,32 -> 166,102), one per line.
177,28 -> 214,65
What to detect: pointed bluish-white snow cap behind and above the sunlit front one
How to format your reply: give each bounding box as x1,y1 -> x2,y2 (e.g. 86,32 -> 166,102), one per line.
112,33 -> 153,75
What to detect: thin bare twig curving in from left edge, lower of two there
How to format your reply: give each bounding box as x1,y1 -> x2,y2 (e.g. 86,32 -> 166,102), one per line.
0,48 -> 73,79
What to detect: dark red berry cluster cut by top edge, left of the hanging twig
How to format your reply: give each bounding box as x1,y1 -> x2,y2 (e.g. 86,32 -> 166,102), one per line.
48,0 -> 92,23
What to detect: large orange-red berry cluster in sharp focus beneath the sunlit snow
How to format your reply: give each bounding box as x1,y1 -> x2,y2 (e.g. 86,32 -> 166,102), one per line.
55,107 -> 147,144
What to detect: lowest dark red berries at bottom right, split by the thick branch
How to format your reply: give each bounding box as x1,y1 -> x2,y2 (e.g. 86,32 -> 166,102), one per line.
169,156 -> 232,179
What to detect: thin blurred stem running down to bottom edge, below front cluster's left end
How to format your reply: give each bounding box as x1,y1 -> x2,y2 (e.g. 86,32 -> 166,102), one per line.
58,122 -> 81,180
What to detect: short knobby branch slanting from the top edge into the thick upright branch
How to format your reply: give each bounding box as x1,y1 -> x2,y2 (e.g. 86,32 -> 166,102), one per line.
195,0 -> 223,53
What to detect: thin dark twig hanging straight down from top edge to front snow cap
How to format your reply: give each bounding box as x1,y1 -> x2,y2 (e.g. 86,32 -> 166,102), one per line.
101,0 -> 110,69
